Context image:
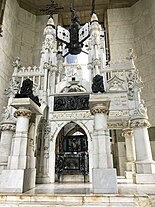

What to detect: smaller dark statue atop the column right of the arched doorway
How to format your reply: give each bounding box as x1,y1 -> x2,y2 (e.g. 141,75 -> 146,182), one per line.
92,75 -> 105,93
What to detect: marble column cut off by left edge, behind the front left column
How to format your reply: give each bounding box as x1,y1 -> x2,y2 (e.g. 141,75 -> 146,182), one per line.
0,119 -> 15,168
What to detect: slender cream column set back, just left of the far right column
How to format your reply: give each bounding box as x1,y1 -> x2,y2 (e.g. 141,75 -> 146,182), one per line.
122,128 -> 136,179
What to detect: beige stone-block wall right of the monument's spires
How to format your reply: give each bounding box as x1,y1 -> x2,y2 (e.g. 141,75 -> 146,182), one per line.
107,0 -> 155,126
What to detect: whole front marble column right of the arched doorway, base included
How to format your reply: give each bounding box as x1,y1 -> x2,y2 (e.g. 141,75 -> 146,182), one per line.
89,94 -> 117,193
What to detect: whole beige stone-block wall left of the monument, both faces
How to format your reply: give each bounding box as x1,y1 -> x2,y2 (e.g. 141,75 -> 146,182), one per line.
0,0 -> 48,114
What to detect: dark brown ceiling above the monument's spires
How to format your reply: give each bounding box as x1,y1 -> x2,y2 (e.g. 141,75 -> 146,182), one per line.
17,0 -> 138,26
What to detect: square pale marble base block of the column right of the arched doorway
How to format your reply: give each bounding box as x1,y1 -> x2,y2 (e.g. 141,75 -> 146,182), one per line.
92,168 -> 118,194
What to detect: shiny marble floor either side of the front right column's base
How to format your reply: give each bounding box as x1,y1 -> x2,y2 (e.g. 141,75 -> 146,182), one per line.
25,178 -> 155,195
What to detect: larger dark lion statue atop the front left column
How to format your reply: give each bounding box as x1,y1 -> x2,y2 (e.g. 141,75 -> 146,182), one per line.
15,79 -> 41,106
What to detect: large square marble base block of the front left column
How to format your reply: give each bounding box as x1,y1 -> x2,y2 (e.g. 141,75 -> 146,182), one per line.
0,169 -> 36,193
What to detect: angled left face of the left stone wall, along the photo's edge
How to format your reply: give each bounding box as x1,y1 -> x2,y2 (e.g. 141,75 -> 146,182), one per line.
0,0 -> 18,114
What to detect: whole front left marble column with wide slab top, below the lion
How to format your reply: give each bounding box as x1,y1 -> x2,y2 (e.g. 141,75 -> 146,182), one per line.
0,98 -> 41,193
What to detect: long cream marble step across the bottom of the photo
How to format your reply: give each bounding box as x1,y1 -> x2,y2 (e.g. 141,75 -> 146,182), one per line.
0,194 -> 155,207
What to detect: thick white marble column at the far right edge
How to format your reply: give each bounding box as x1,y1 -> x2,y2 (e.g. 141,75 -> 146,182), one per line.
131,117 -> 155,183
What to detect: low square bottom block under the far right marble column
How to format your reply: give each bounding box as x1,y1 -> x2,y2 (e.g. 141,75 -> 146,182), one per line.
133,174 -> 155,184
